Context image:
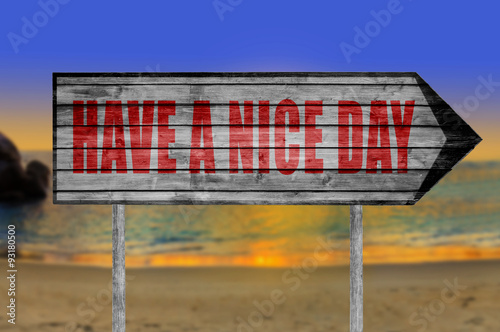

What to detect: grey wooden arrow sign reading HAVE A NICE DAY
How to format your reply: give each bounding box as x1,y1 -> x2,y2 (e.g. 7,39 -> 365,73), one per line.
53,73 -> 481,205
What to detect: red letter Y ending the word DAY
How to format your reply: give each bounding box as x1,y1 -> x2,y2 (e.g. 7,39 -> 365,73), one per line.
391,100 -> 415,173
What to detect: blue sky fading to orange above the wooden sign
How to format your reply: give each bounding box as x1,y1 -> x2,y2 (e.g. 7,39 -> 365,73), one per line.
0,0 -> 500,160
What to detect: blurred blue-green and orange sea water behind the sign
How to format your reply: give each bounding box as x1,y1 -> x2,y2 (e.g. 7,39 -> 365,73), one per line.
0,152 -> 500,266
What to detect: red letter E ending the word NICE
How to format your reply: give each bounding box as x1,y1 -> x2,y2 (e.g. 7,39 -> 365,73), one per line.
305,100 -> 323,173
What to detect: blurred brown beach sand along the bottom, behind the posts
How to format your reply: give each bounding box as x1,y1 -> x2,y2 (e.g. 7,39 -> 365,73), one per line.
0,261 -> 500,332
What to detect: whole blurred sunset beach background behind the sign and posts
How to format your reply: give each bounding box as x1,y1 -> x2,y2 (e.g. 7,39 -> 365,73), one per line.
0,0 -> 500,331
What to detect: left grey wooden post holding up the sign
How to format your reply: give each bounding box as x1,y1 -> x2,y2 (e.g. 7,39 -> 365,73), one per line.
112,204 -> 125,332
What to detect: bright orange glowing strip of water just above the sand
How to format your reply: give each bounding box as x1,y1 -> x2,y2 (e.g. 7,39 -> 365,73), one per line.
19,246 -> 500,268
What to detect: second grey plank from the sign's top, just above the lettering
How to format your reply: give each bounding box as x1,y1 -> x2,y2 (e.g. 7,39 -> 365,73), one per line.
57,84 -> 428,105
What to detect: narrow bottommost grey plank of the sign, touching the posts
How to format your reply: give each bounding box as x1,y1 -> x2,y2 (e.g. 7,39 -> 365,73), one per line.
54,191 -> 416,205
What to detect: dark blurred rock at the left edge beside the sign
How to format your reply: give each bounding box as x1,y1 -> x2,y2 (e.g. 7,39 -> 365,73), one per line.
0,133 -> 50,203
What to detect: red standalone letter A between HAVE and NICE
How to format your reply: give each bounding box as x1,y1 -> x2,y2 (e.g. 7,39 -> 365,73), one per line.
189,100 -> 215,173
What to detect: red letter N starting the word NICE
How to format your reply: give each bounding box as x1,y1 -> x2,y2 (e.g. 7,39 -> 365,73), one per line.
229,100 -> 253,173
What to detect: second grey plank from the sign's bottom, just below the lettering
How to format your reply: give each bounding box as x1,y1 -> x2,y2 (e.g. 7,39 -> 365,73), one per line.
53,170 -> 429,191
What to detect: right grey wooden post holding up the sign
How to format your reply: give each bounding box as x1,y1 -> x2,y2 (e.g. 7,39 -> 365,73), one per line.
350,205 -> 363,332
